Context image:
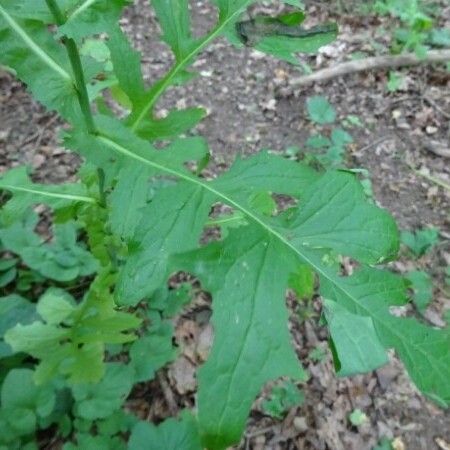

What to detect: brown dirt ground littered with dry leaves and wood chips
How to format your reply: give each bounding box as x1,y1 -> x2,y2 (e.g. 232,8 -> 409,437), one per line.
0,0 -> 450,450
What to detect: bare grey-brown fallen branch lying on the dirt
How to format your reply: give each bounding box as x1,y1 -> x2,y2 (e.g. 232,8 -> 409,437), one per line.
290,50 -> 450,86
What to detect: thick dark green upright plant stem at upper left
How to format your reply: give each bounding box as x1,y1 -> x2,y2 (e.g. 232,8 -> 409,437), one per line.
45,0 -> 97,134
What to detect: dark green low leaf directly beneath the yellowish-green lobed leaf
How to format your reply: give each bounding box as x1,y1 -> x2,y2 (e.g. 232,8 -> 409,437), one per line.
72,363 -> 134,420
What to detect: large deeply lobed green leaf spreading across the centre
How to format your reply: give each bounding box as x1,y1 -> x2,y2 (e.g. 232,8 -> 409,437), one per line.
65,116 -> 448,448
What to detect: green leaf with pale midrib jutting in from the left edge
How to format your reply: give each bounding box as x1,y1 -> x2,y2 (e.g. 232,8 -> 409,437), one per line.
0,166 -> 96,225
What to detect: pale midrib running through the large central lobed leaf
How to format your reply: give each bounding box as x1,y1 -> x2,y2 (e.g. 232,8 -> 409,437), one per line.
96,136 -> 446,390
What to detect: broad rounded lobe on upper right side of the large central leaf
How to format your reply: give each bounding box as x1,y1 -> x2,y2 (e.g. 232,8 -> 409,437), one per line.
283,171 -> 398,263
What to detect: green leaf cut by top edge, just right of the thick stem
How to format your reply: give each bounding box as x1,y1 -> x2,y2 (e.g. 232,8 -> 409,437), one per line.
58,0 -> 128,41
